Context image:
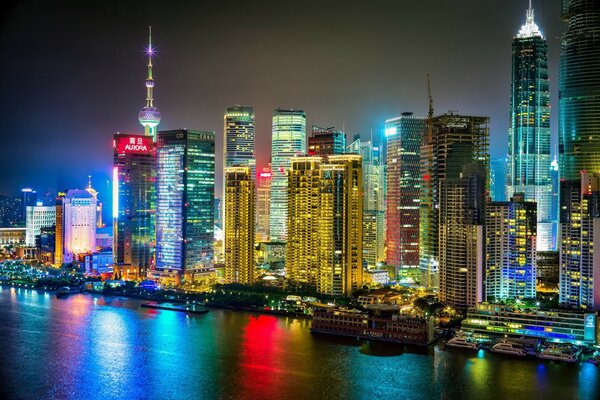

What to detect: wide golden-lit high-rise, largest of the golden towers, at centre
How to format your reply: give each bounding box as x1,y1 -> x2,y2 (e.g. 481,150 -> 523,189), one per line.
286,154 -> 363,296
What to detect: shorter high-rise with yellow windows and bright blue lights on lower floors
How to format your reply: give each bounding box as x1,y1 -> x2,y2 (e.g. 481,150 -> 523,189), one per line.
485,193 -> 537,301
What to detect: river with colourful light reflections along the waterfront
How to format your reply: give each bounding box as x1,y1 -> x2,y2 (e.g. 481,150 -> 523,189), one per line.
0,288 -> 600,400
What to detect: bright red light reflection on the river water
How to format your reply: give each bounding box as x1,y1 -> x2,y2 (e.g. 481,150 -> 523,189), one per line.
239,315 -> 289,399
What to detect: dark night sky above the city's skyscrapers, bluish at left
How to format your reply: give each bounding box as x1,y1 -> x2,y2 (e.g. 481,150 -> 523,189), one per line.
0,0 -> 566,201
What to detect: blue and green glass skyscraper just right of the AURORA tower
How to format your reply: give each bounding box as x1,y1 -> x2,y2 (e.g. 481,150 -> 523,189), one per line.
156,129 -> 214,282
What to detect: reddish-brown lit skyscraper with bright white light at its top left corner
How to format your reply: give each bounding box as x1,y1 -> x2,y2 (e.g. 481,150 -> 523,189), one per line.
385,112 -> 426,272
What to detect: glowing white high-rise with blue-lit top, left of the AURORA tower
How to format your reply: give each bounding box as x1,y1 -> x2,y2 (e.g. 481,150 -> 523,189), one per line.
63,189 -> 97,254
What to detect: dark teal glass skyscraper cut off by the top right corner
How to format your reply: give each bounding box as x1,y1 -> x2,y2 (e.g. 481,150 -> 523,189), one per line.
558,0 -> 600,181
